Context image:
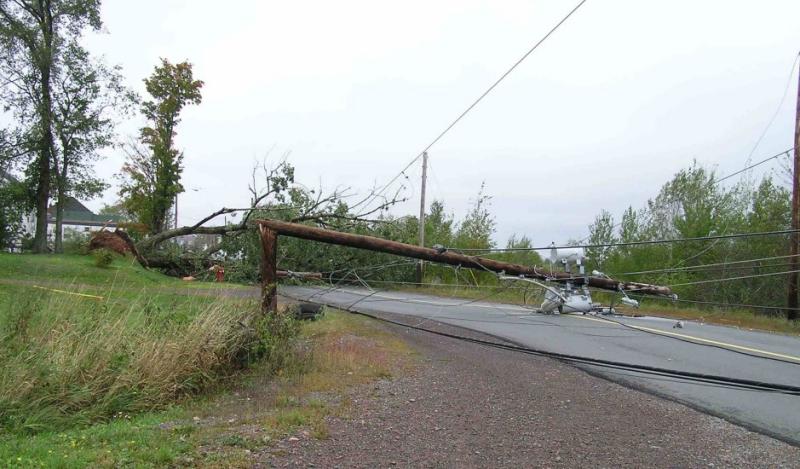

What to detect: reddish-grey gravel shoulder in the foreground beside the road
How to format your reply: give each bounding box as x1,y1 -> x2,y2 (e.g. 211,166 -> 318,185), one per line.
258,308 -> 800,468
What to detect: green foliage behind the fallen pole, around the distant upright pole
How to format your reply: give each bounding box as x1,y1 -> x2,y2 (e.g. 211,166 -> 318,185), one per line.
219,177 -> 540,286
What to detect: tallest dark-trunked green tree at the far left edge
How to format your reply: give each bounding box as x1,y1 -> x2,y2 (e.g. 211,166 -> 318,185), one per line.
0,0 -> 101,252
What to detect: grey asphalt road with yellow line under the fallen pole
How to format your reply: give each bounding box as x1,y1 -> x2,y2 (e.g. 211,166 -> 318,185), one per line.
281,287 -> 800,445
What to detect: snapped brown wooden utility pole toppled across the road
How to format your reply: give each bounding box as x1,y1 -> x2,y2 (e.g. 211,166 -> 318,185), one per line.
257,220 -> 672,296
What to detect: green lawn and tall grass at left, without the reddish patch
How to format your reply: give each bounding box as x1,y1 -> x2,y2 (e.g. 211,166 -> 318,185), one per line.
0,254 -> 288,467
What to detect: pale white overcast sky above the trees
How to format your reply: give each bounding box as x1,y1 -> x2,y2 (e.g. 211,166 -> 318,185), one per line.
81,0 -> 800,245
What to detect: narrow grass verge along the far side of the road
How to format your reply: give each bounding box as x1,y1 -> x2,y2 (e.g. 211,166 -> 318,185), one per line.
400,285 -> 800,335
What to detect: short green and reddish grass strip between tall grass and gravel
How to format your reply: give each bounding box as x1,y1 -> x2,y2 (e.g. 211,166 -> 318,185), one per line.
0,311 -> 415,468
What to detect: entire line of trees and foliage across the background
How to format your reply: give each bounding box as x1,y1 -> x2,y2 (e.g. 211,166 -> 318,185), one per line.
0,0 -> 791,320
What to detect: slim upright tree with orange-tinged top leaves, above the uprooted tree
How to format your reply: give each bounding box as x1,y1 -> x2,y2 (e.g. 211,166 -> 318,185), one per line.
120,59 -> 203,234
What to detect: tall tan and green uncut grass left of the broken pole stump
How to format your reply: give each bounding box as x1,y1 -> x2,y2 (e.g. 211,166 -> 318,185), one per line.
0,289 -> 293,432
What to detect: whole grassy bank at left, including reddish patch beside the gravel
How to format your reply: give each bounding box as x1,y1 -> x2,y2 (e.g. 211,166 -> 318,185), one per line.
0,254 -> 412,467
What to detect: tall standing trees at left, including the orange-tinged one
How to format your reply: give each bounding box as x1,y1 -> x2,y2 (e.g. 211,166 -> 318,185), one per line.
0,0 -> 203,253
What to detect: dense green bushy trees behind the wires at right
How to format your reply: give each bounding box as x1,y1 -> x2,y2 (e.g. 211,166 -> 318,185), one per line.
587,164 -> 791,312
